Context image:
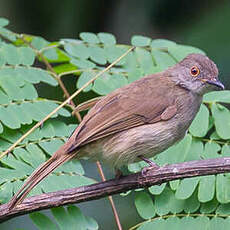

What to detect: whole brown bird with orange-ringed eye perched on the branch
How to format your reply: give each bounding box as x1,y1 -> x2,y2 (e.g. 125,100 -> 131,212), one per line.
9,54 -> 224,209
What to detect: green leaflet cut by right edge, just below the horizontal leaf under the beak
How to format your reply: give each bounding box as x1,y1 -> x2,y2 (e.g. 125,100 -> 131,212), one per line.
211,103 -> 230,139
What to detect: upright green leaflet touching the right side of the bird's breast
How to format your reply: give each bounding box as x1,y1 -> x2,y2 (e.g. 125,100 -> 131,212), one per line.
189,104 -> 209,137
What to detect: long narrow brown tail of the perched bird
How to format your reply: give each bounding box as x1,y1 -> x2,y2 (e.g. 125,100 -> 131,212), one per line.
8,153 -> 75,210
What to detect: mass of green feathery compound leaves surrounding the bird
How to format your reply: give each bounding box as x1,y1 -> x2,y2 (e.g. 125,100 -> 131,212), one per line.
0,18 -> 230,230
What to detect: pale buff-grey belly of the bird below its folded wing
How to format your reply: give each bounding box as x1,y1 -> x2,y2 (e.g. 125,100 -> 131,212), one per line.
80,117 -> 188,168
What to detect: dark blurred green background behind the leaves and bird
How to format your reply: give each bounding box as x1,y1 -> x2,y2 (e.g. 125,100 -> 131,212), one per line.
0,0 -> 230,230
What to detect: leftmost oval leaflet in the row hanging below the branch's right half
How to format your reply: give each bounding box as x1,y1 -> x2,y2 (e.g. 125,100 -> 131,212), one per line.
135,192 -> 155,219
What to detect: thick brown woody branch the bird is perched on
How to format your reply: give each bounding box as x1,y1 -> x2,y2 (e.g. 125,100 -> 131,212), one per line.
0,157 -> 230,222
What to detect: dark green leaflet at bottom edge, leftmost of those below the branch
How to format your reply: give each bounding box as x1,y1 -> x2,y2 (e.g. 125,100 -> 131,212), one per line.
29,212 -> 57,230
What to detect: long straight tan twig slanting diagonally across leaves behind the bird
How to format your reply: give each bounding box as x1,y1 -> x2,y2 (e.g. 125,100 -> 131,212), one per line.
0,47 -> 135,159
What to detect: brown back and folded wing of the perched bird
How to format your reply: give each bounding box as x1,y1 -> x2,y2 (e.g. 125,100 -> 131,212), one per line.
67,74 -> 177,152
